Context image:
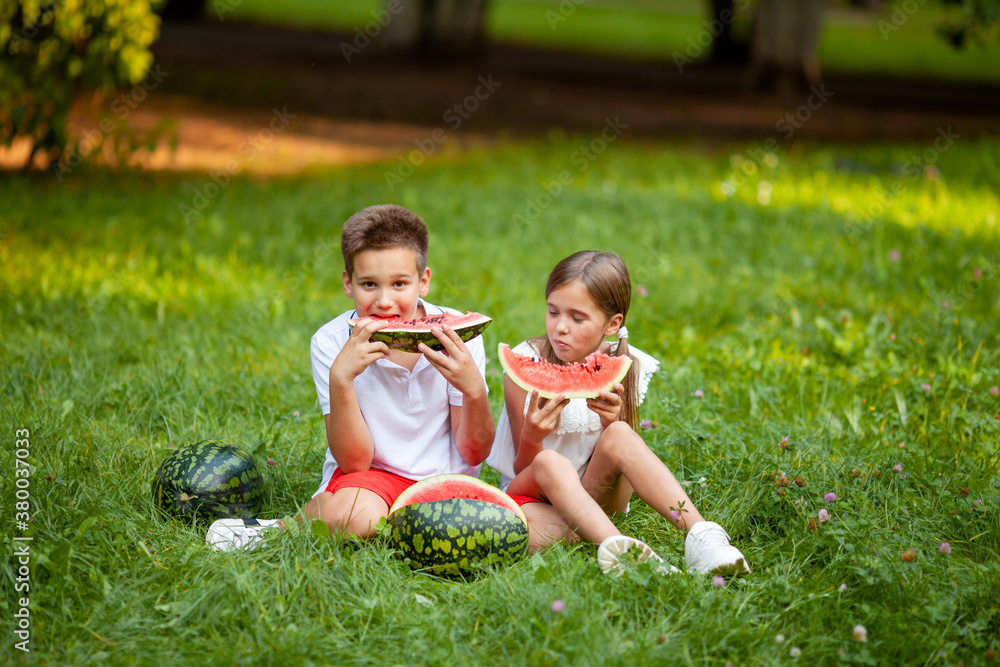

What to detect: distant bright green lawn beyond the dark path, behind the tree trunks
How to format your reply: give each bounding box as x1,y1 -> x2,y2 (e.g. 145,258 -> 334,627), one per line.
215,0 -> 1000,82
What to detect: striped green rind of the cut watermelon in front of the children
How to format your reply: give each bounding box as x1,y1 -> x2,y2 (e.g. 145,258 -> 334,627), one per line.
389,498 -> 528,576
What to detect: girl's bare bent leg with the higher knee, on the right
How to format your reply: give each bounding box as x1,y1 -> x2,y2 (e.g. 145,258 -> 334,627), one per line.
581,422 -> 705,530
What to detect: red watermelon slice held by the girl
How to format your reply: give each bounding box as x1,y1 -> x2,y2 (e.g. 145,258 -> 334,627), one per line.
497,343 -> 632,398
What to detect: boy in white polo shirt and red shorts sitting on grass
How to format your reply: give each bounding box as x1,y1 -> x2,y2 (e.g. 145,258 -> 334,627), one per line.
206,205 -> 495,549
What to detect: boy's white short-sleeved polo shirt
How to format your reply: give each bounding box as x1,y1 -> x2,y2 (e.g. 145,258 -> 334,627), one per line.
310,299 -> 486,496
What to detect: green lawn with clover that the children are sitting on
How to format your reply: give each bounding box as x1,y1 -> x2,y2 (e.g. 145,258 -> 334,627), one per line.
0,136 -> 1000,666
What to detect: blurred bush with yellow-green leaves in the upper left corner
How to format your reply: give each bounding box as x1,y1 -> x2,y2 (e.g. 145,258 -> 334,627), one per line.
0,0 -> 159,166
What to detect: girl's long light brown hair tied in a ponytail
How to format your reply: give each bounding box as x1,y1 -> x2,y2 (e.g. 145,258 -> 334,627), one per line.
532,250 -> 639,428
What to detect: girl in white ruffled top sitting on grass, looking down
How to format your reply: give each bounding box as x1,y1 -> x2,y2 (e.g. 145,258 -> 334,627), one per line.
487,251 -> 749,576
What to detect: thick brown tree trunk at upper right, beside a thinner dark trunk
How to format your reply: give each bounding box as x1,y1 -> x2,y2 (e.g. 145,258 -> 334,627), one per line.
750,0 -> 823,93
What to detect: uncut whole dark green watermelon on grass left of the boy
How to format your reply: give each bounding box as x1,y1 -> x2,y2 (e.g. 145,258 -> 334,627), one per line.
151,440 -> 264,523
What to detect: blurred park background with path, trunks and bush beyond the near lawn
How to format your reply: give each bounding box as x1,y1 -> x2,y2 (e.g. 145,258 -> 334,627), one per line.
0,0 -> 1000,172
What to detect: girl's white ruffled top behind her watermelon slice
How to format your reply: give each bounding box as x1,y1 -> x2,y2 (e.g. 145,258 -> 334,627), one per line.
486,341 -> 660,491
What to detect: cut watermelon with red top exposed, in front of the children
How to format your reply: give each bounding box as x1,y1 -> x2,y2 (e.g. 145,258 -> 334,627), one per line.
388,475 -> 528,576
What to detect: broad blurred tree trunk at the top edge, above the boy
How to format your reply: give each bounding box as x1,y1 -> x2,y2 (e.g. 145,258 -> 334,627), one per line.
382,0 -> 487,55
